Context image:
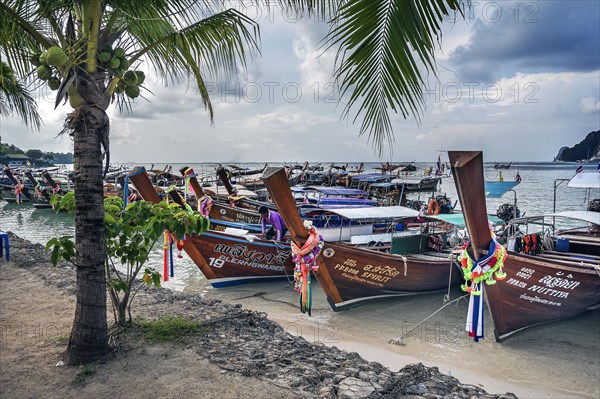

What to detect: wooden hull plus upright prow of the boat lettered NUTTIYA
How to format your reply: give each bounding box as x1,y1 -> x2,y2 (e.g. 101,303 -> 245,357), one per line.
448,151 -> 600,341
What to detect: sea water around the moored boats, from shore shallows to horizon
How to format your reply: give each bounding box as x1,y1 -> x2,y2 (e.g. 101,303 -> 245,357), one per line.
0,163 -> 600,398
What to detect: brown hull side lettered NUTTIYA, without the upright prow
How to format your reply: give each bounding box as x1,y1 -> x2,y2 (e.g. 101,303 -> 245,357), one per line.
485,253 -> 600,341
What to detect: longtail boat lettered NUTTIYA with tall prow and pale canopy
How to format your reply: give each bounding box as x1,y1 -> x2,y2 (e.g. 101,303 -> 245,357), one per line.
448,151 -> 600,341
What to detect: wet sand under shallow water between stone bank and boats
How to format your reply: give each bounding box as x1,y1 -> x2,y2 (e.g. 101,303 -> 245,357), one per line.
193,281 -> 600,398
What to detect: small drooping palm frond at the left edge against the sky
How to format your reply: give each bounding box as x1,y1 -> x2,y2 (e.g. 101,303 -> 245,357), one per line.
0,58 -> 42,130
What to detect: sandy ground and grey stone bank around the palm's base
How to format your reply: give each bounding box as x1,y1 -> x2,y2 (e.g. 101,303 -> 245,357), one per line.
0,234 -> 516,399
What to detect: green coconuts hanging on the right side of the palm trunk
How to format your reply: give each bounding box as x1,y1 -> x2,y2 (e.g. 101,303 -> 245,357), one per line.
98,44 -> 146,98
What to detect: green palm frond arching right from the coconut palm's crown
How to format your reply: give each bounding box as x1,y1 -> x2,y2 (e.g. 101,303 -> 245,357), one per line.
111,0 -> 260,120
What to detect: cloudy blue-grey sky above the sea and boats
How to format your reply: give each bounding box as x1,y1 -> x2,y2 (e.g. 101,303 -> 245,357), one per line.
0,0 -> 600,163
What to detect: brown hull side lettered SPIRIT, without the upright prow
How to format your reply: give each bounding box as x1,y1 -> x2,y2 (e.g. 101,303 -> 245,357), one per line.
315,243 -> 461,311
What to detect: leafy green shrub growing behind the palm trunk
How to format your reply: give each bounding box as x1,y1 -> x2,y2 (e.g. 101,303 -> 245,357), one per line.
46,195 -> 209,325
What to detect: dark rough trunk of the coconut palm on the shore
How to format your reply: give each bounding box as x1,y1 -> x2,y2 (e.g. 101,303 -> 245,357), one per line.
65,105 -> 109,365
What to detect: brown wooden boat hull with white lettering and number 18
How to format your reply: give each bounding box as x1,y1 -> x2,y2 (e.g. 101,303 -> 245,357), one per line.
186,230 -> 294,288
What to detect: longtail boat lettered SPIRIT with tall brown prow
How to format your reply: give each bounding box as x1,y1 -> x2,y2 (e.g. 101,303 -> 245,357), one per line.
263,168 -> 460,311
